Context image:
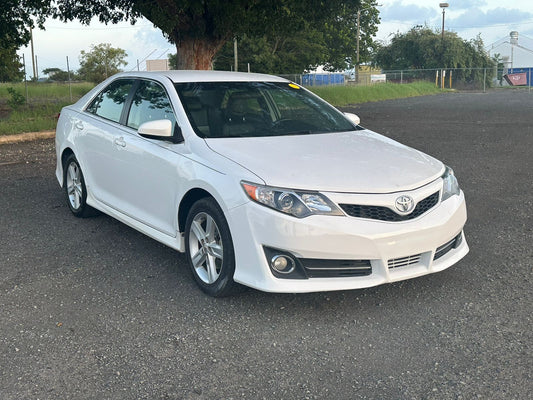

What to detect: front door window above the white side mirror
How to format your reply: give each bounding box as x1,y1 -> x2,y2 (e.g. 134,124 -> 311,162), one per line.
127,81 -> 176,129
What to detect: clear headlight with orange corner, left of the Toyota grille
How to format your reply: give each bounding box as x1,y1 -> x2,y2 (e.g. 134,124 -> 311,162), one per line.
241,182 -> 344,218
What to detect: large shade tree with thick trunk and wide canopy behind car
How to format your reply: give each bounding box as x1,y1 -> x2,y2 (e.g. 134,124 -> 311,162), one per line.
46,0 -> 361,69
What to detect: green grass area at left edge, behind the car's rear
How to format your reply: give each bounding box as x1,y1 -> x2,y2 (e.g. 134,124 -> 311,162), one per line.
0,82 -> 94,135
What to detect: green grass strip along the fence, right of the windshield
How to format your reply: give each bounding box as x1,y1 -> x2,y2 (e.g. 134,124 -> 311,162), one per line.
308,82 -> 441,107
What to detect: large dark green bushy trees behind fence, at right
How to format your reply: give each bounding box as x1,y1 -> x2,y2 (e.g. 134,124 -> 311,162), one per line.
374,26 -> 494,84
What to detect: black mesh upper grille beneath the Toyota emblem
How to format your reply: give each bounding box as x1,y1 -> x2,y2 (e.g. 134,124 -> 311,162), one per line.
339,192 -> 439,222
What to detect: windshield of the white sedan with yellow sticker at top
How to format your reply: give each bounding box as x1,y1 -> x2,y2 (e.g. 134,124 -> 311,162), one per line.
175,82 -> 356,138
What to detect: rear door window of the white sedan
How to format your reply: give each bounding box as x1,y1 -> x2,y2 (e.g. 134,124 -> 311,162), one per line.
86,79 -> 133,122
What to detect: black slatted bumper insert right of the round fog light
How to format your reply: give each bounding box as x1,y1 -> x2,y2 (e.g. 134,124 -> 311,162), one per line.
298,258 -> 372,278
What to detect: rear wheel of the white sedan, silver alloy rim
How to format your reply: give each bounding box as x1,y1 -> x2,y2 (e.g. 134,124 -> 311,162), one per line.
63,154 -> 98,218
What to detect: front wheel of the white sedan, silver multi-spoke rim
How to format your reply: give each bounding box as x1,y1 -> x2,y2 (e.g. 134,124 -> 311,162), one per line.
185,197 -> 240,297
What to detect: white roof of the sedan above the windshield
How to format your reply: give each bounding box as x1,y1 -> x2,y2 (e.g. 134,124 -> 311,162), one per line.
110,70 -> 289,83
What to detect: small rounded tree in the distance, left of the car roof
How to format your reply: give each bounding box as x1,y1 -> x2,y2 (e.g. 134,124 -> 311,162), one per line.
78,43 -> 127,83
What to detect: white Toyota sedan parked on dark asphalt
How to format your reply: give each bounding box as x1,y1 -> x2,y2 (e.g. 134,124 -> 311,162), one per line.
56,71 -> 468,296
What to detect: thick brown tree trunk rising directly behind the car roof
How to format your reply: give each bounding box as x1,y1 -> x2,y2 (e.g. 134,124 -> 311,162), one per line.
176,38 -> 225,70
